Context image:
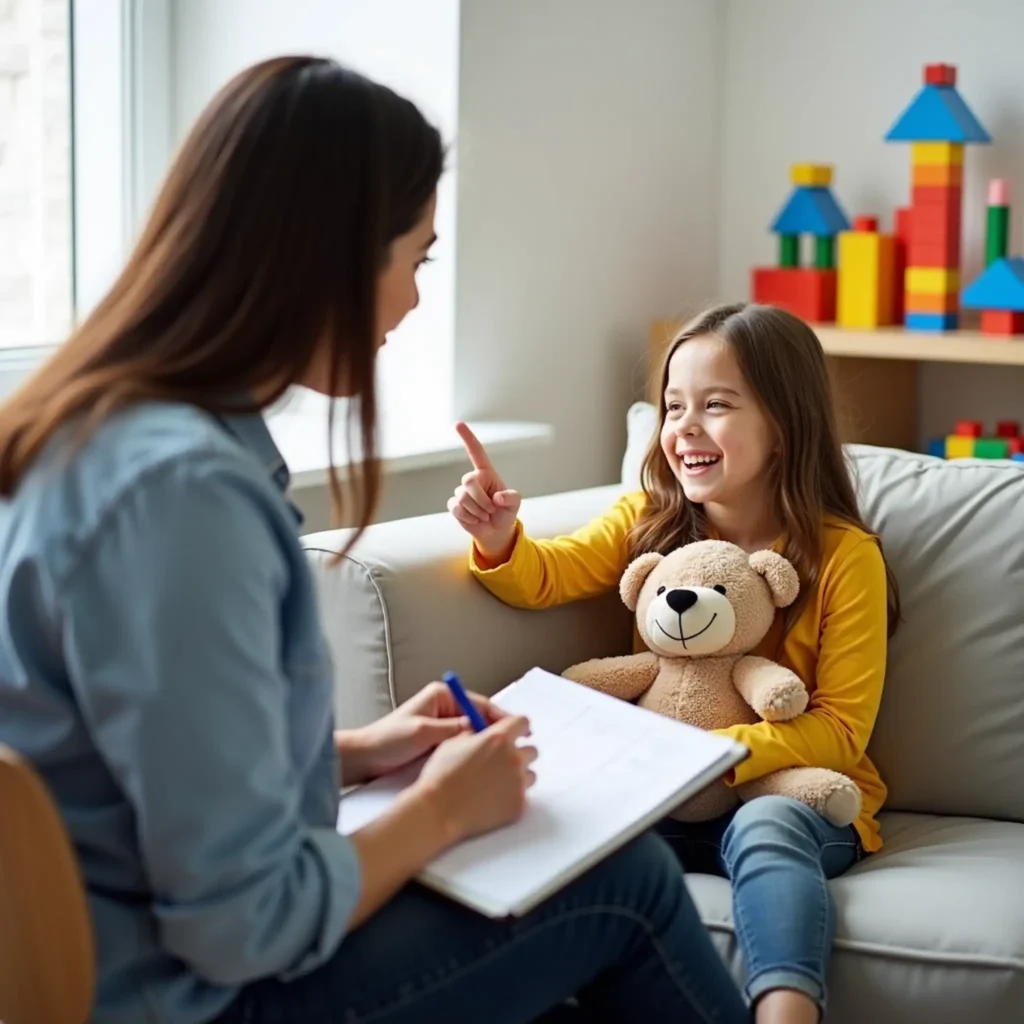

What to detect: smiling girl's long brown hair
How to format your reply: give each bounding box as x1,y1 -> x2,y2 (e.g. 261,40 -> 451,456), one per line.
630,303 -> 900,636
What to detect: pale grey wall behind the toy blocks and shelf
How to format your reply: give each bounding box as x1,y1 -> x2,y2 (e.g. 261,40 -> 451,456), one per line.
720,0 -> 1024,448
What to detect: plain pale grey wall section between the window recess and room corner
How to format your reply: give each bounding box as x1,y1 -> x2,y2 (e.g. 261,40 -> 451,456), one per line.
456,0 -> 724,493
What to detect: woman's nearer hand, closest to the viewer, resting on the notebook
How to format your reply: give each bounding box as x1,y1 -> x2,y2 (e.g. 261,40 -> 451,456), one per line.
413,716 -> 537,844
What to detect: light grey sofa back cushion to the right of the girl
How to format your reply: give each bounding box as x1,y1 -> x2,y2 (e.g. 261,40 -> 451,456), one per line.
849,445 -> 1024,823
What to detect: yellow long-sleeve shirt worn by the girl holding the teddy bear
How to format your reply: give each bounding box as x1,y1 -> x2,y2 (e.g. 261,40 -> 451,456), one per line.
470,492 -> 888,852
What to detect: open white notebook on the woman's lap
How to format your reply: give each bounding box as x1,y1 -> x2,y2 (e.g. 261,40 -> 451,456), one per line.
338,669 -> 749,918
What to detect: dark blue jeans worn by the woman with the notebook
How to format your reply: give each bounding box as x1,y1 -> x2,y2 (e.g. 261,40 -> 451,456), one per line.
211,833 -> 750,1024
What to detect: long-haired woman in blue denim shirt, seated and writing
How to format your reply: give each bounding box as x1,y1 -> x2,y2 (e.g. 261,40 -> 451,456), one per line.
0,57 -> 745,1024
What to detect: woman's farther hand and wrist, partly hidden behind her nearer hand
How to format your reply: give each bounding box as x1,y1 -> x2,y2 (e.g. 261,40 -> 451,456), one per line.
335,683 -> 508,785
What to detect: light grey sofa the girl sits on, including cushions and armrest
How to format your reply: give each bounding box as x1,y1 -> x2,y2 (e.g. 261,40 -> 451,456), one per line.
305,446 -> 1024,1024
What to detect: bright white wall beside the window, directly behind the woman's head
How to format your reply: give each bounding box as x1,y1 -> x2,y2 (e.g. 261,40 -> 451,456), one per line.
172,0 -> 459,436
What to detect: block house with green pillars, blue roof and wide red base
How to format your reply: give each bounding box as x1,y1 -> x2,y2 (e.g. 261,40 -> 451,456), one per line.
751,164 -> 850,324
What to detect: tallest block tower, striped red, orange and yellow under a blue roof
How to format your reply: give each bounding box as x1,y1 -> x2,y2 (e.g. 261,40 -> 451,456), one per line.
886,65 -> 992,331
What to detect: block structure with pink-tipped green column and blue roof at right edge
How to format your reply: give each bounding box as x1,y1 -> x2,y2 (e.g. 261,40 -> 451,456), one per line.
961,178 -> 1024,337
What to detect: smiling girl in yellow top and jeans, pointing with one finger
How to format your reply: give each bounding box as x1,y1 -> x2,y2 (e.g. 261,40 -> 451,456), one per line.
449,304 -> 898,1024
